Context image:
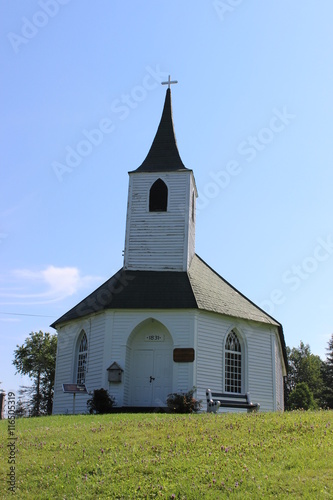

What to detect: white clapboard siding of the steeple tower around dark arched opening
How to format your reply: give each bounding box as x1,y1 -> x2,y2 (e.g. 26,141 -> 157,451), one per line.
124,171 -> 194,271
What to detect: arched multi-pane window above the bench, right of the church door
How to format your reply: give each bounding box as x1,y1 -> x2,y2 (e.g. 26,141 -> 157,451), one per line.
224,330 -> 242,393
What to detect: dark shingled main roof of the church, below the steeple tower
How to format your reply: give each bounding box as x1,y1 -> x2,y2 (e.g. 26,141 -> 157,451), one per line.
51,255 -> 287,363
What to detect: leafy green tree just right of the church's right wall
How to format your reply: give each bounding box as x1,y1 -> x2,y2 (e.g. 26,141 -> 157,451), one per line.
285,341 -> 324,410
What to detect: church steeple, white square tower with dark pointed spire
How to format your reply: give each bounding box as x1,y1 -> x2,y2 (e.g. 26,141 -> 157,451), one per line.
124,83 -> 197,271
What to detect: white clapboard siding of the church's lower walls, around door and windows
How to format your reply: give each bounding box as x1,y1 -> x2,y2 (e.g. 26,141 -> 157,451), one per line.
54,310 -> 283,413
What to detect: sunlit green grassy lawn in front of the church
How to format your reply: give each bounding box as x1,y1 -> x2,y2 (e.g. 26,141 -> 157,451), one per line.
0,411 -> 333,499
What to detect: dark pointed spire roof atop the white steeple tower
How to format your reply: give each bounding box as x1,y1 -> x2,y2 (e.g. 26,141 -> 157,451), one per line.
135,89 -> 189,172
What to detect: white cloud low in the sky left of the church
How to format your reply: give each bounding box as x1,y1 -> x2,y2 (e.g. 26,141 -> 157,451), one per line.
0,265 -> 103,305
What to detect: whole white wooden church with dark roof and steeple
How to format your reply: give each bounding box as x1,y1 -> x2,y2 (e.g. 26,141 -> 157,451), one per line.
51,78 -> 287,414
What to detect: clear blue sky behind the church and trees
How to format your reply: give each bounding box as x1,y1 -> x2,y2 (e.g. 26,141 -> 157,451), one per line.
0,0 -> 333,396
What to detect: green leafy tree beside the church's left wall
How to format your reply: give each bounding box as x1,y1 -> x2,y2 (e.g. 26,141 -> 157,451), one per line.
13,331 -> 57,416
